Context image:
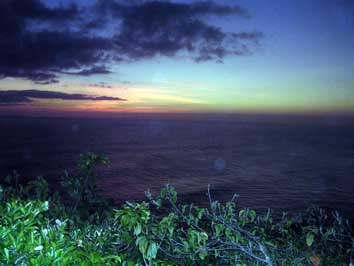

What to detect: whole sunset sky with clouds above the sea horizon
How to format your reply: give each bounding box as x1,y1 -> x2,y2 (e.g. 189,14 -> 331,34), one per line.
0,0 -> 354,114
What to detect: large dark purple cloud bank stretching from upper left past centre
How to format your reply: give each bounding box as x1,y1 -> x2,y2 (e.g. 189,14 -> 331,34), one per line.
0,0 -> 261,84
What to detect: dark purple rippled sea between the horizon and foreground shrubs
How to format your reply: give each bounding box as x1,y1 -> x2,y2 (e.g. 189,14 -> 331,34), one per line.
0,115 -> 354,216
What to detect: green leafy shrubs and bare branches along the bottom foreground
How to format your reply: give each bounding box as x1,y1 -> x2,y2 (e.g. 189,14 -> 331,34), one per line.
0,153 -> 354,266
